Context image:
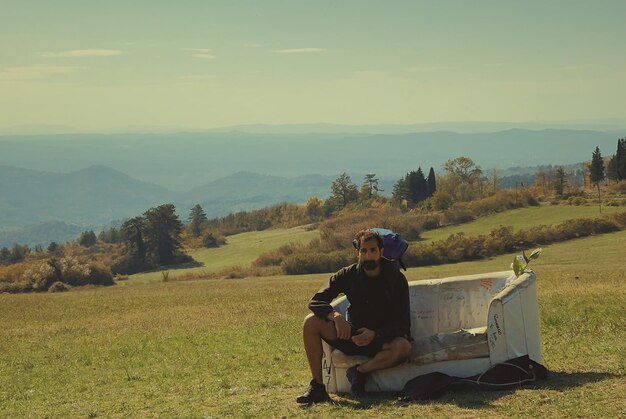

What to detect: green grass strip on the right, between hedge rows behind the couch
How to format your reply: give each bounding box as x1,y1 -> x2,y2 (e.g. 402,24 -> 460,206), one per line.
421,205 -> 624,241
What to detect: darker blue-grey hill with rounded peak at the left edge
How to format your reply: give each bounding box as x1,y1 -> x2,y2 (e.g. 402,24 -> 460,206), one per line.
0,166 -> 176,230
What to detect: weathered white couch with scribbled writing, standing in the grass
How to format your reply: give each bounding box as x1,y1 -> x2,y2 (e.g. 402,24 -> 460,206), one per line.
322,271 -> 543,393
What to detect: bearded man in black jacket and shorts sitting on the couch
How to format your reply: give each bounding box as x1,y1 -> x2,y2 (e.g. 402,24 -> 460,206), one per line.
296,230 -> 411,404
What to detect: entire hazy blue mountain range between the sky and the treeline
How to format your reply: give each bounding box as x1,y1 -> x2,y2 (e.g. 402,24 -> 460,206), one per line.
0,126 -> 623,245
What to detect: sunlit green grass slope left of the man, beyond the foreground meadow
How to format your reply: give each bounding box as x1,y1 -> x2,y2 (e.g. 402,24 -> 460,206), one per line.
124,227 -> 319,283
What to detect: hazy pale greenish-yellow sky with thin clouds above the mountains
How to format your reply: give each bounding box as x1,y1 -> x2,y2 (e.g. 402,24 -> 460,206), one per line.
0,0 -> 626,130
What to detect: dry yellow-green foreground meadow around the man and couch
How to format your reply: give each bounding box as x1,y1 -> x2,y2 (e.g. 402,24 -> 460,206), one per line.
0,217 -> 626,418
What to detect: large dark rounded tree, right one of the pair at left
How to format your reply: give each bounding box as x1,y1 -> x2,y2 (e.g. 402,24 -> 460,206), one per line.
143,204 -> 183,265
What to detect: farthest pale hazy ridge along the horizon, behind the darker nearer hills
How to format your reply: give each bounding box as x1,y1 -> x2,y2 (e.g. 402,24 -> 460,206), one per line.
0,129 -> 626,192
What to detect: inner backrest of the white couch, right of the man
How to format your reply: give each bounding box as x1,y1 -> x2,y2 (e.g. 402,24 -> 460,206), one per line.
409,271 -> 515,337
